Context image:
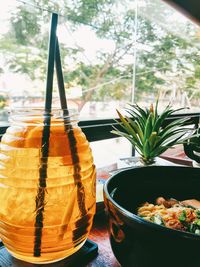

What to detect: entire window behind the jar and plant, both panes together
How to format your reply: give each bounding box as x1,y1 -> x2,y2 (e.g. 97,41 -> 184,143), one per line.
0,0 -> 200,169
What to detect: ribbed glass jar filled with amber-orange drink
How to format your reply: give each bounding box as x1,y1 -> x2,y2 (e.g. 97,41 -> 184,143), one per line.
0,109 -> 96,264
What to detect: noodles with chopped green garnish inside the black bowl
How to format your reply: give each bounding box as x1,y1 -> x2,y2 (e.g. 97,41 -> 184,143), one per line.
137,197 -> 200,235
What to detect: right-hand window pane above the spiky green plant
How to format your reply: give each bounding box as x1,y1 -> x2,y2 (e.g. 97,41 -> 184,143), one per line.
135,0 -> 200,112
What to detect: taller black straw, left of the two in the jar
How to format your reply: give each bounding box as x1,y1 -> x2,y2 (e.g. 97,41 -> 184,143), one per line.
33,13 -> 58,257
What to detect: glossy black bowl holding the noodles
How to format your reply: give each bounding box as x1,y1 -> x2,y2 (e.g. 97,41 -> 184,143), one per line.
104,166 -> 200,267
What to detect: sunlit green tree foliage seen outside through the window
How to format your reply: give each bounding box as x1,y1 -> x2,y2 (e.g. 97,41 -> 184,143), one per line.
0,0 -> 200,110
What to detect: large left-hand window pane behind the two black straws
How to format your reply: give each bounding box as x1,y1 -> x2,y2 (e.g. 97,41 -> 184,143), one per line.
0,0 -> 134,122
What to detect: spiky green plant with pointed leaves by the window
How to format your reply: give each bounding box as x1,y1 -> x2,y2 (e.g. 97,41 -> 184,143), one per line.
112,100 -> 189,165
